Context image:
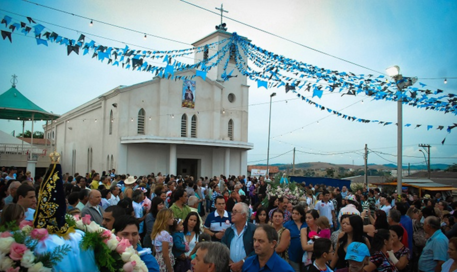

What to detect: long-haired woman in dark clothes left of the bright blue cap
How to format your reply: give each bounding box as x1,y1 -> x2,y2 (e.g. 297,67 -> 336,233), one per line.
330,215 -> 370,269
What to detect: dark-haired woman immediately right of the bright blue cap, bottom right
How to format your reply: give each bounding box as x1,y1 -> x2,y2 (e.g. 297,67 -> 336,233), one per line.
364,229 -> 398,272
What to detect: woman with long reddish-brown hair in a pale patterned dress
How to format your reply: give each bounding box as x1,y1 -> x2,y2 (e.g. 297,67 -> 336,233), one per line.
151,209 -> 175,272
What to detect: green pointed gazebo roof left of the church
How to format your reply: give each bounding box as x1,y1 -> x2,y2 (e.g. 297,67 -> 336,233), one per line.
0,85 -> 59,121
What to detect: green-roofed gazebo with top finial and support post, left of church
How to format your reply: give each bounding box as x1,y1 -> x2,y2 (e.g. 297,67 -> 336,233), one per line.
0,75 -> 59,176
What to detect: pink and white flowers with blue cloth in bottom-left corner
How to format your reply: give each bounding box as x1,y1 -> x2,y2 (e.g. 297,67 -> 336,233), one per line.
0,221 -> 71,272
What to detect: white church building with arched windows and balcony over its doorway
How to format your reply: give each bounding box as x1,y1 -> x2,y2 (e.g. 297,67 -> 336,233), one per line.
45,30 -> 253,177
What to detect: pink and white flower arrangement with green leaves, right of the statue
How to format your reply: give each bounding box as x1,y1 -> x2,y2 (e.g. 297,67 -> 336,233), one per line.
70,214 -> 148,272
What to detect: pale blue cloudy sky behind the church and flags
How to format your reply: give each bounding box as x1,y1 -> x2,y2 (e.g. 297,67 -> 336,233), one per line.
0,0 -> 457,168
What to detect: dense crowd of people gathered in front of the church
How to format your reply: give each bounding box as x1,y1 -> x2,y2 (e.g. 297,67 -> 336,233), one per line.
0,167 -> 457,272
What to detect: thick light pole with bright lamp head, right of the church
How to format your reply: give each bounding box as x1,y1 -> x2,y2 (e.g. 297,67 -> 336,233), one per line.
386,65 -> 417,196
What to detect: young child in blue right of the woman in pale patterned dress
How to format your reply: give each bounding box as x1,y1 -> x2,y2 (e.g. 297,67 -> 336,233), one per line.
170,219 -> 190,272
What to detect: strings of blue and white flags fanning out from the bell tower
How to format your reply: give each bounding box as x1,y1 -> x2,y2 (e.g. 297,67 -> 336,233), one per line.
0,12 -> 457,140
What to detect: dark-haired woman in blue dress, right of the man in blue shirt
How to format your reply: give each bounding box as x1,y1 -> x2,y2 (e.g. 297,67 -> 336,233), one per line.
284,206 -> 307,272
